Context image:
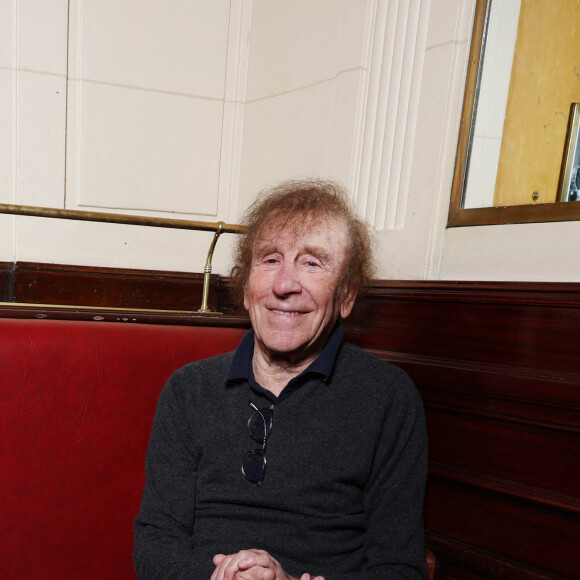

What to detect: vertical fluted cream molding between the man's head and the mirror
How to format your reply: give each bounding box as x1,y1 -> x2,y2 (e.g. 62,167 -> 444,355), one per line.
352,0 -> 429,231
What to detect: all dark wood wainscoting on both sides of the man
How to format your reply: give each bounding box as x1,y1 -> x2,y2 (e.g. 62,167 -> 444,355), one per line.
0,264 -> 580,580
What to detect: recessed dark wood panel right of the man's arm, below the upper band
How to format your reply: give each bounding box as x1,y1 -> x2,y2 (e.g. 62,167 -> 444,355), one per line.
427,404 -> 580,502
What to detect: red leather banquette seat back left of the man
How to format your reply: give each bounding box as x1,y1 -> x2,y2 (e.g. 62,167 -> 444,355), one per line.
0,318 -> 245,580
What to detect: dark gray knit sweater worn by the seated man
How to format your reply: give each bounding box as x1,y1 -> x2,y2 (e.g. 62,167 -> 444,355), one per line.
134,344 -> 427,580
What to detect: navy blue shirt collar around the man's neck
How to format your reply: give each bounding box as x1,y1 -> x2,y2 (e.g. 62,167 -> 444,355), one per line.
225,322 -> 343,405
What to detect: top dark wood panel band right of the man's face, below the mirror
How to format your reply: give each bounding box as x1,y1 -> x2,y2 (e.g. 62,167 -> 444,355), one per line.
344,282 -> 580,373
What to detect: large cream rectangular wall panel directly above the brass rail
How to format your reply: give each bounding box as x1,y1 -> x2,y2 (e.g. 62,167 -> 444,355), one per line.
65,0 -> 236,221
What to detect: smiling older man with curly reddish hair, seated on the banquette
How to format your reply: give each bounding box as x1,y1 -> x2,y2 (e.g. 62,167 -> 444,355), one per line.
134,182 -> 427,580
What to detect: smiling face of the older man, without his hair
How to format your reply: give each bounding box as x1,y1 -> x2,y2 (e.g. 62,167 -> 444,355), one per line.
244,218 -> 356,366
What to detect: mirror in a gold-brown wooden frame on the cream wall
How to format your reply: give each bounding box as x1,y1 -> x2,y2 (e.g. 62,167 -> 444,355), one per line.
449,0 -> 580,226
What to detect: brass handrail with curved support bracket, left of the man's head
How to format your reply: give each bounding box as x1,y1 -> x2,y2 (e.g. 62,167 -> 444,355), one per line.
0,203 -> 245,314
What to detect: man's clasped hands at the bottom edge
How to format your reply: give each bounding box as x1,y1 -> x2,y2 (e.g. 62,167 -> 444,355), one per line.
210,550 -> 324,580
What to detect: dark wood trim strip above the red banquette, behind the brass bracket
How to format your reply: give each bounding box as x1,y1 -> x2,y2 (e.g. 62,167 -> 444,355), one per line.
0,262 -> 249,327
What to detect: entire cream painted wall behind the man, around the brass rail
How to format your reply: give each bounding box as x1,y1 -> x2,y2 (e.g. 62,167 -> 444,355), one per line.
0,0 -> 580,280
